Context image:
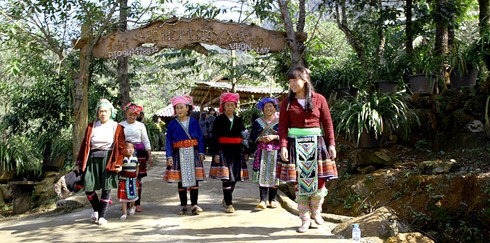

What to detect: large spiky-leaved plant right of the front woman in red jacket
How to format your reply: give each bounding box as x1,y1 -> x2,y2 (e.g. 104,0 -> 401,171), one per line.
331,91 -> 416,148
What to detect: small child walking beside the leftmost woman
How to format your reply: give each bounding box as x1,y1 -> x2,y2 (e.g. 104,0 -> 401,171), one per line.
117,142 -> 139,220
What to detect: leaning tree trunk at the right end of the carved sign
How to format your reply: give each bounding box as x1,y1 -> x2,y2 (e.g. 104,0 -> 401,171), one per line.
277,0 -> 306,66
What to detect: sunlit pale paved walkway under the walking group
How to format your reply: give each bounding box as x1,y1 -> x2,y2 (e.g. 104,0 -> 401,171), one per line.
0,153 -> 351,243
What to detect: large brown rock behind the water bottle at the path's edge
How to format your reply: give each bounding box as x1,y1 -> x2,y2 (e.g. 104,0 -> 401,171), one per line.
332,207 -> 412,240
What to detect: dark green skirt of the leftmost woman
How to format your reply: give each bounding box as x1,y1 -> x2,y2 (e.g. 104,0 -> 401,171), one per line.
83,150 -> 118,192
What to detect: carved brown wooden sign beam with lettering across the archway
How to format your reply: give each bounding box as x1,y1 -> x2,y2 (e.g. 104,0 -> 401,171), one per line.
80,18 -> 287,58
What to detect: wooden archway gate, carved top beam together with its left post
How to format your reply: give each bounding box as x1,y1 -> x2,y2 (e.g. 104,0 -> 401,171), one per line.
73,18 -> 296,158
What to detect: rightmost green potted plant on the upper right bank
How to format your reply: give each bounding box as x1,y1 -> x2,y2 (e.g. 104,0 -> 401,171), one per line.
448,44 -> 480,89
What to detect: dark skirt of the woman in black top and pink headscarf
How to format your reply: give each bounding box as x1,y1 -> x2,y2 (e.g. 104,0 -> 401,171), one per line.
209,144 -> 248,181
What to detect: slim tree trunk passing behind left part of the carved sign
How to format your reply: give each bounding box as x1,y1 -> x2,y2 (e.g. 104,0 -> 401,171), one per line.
117,0 -> 130,109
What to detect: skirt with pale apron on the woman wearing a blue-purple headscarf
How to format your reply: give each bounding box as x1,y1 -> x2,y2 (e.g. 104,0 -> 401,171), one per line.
252,142 -> 280,187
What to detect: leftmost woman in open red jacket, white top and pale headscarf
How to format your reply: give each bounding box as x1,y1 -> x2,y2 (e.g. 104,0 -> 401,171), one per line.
76,99 -> 126,225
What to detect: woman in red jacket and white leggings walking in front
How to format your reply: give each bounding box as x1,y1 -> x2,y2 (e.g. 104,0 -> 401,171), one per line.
277,66 -> 337,233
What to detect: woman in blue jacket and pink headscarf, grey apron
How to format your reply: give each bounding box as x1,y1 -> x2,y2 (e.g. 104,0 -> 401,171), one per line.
164,95 -> 206,215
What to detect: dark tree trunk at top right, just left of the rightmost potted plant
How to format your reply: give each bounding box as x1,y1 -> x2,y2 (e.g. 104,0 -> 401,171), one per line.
434,0 -> 449,55
